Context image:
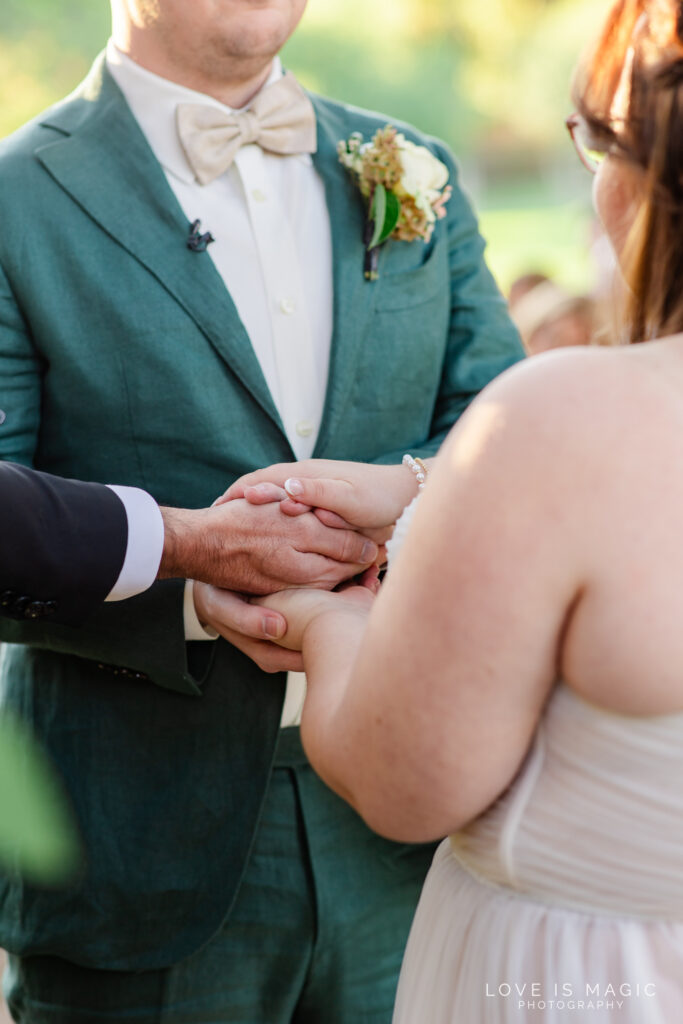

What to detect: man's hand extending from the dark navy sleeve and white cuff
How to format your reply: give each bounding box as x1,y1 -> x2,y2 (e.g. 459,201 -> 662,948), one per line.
160,500 -> 379,594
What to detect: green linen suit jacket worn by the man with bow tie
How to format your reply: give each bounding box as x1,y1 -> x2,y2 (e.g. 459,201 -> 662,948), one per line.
0,57 -> 522,970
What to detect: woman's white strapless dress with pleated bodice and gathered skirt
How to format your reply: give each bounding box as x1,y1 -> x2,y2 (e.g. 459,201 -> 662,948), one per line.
391,495 -> 683,1024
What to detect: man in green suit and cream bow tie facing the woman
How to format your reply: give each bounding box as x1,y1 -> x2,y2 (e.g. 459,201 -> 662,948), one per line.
0,0 -> 521,1024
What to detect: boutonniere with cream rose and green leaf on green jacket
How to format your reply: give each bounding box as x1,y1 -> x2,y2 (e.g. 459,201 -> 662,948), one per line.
337,125 -> 453,281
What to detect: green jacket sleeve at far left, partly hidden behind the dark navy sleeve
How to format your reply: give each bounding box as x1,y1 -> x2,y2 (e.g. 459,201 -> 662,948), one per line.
0,260 -> 202,695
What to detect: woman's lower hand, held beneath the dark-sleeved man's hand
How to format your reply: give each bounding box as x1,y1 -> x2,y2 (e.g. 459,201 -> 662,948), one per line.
252,569 -> 379,651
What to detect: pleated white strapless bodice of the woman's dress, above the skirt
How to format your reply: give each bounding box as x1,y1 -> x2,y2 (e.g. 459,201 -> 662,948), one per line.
451,683 -> 683,921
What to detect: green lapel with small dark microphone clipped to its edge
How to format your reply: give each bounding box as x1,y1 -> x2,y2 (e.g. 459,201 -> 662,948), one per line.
36,57 -> 284,432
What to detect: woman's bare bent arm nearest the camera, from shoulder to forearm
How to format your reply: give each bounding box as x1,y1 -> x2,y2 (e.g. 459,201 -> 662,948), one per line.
259,352 -> 585,841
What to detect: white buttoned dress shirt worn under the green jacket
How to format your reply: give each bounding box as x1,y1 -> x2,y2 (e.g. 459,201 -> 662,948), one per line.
106,40 -> 333,724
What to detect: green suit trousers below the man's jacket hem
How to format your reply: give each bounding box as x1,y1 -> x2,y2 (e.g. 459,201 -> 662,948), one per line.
5,729 -> 433,1024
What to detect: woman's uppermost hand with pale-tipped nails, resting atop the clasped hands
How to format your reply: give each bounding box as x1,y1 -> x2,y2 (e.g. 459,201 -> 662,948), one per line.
217,459 -> 417,544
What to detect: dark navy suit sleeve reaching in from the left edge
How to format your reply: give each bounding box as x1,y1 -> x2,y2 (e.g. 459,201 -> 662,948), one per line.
0,463 -> 128,626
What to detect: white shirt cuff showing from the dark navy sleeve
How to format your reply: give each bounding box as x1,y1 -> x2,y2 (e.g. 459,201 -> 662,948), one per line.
104,484 -> 164,601
